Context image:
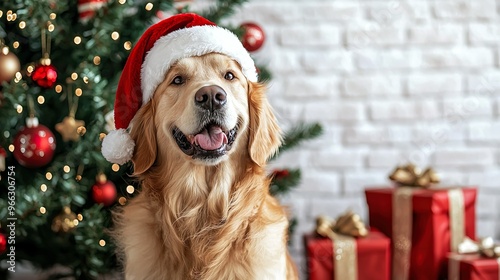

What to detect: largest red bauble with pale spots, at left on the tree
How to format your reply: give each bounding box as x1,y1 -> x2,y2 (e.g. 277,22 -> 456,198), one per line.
13,118 -> 56,168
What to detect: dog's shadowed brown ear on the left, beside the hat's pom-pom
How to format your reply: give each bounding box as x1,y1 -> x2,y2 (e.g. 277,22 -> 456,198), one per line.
130,100 -> 157,176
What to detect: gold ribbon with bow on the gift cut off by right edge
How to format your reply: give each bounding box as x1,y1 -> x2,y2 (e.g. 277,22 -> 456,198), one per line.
448,237 -> 500,280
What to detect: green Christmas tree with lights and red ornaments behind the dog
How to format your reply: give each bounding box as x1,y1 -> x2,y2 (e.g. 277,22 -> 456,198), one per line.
0,0 -> 321,279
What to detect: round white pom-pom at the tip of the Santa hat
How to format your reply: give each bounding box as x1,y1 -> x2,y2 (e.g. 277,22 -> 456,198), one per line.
101,128 -> 135,165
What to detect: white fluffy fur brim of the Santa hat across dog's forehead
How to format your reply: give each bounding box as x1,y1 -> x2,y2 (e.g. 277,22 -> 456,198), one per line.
141,25 -> 257,105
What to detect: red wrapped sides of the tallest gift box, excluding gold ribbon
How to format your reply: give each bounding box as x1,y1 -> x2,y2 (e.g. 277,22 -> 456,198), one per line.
365,187 -> 476,280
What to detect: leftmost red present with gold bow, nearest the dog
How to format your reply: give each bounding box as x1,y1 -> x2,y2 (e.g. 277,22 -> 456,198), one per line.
304,213 -> 390,280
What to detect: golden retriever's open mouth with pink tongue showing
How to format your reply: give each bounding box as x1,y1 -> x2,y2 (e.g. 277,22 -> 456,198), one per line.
172,122 -> 238,159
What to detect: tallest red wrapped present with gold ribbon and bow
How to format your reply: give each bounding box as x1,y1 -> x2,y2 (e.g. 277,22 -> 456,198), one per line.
365,165 -> 477,280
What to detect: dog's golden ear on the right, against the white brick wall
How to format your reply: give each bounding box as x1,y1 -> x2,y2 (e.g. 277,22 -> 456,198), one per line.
248,82 -> 282,166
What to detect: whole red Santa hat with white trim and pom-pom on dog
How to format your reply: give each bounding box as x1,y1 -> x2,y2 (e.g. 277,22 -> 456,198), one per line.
102,14 -> 257,164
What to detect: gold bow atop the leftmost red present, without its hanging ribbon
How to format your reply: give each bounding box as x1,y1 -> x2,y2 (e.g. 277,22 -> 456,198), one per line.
316,211 -> 368,239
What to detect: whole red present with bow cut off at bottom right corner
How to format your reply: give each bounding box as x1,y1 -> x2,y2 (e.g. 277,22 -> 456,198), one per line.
448,237 -> 500,280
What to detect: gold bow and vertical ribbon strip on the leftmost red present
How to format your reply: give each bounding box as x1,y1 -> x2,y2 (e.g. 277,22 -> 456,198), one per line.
316,212 -> 368,280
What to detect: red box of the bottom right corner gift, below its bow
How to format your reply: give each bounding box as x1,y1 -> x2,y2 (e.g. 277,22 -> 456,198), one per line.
448,254 -> 500,280
